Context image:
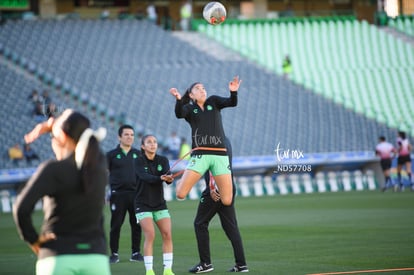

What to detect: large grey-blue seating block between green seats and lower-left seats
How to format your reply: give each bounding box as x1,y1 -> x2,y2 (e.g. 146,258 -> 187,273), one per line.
0,17 -> 404,160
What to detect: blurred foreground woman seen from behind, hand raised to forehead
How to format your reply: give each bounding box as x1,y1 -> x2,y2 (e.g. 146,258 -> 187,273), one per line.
13,110 -> 110,275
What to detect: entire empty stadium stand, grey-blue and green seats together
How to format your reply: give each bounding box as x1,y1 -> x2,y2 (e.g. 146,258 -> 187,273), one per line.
0,19 -> 414,203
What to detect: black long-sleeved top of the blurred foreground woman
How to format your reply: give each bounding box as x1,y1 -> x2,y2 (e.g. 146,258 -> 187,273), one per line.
14,154 -> 108,259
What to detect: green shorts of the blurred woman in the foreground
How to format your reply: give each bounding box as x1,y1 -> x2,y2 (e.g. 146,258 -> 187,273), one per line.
36,254 -> 111,275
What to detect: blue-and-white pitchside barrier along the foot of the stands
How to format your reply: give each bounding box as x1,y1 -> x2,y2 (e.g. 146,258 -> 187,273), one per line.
0,151 -> 396,215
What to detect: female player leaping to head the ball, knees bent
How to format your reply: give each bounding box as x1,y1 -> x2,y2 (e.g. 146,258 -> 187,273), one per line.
170,76 -> 241,205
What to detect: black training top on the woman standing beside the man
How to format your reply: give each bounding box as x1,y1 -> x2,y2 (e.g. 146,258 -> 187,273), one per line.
135,154 -> 170,213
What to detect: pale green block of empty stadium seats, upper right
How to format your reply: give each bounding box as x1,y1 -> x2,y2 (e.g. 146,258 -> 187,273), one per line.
198,17 -> 414,135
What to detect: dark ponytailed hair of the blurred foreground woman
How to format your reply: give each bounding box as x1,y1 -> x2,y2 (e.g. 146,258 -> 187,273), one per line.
62,112 -> 106,193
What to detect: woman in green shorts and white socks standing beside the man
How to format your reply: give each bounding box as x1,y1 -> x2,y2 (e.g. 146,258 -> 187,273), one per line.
135,135 -> 174,275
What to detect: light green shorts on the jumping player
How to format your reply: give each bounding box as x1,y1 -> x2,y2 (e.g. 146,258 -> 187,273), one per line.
187,155 -> 231,176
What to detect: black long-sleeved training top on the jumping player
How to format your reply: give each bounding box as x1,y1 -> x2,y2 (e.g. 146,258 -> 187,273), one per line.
175,92 -> 237,155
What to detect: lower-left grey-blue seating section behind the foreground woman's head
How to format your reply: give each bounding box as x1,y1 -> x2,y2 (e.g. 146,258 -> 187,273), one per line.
0,54 -> 123,168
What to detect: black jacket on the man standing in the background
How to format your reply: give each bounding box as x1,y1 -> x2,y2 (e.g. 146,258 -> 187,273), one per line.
106,145 -> 141,192
